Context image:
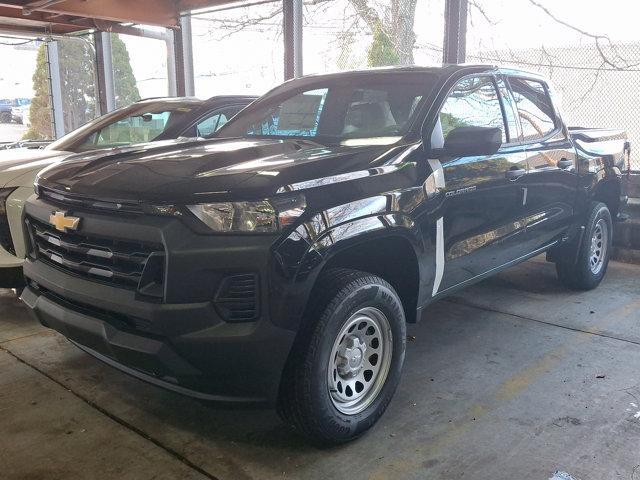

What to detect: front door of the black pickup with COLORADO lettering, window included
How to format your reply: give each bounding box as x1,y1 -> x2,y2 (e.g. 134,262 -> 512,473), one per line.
432,75 -> 527,293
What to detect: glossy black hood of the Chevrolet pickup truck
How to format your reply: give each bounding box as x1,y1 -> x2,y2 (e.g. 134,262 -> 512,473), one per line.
38,139 -> 416,204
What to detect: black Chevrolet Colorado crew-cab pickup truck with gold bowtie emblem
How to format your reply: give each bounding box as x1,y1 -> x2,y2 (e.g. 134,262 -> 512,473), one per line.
22,66 -> 629,443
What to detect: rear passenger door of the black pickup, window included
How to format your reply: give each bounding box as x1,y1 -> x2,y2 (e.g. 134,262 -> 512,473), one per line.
508,76 -> 578,251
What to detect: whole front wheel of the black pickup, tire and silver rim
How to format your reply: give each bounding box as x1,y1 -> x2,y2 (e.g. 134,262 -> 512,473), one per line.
278,269 -> 406,444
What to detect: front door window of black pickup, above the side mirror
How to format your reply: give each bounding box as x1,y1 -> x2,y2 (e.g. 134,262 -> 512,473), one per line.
436,77 -> 507,143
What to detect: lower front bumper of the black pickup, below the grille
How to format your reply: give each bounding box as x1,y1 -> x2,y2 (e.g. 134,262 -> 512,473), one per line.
22,263 -> 294,403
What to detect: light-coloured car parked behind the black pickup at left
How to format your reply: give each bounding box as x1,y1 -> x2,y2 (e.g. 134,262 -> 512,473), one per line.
0,95 -> 256,288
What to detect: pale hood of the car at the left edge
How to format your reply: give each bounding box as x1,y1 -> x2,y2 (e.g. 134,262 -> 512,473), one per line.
0,148 -> 72,188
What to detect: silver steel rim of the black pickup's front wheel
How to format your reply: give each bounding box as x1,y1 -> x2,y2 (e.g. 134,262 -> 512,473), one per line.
327,307 -> 393,415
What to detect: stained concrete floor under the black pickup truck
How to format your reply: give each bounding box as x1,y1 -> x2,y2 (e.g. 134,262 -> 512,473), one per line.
0,259 -> 640,480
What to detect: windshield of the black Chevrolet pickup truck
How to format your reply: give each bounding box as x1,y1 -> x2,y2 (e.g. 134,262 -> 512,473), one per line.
216,72 -> 436,145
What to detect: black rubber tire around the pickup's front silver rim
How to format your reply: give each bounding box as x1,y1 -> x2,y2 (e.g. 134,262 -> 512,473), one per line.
278,269 -> 406,445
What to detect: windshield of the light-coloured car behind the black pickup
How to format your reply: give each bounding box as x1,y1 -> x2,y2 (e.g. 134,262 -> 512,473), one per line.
47,102 -> 200,152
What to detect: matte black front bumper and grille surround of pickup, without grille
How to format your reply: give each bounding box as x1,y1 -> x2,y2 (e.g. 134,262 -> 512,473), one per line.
22,200 -> 295,403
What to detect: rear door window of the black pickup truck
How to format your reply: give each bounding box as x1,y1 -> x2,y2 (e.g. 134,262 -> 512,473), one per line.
509,78 -> 555,141
